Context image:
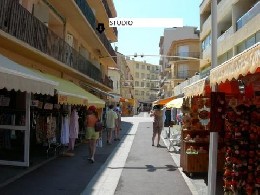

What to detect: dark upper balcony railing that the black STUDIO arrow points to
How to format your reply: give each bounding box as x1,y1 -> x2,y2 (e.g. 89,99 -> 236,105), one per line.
75,0 -> 117,63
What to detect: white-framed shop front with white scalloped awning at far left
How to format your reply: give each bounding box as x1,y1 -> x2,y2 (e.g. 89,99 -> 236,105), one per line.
0,55 -> 58,166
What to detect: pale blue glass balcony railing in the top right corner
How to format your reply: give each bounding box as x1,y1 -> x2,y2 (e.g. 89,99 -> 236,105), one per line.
236,1 -> 260,30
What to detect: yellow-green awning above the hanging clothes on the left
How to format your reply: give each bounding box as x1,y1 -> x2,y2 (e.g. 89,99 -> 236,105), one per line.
41,74 -> 105,108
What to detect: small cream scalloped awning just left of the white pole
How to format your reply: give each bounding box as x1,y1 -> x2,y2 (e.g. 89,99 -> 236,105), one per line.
183,77 -> 208,98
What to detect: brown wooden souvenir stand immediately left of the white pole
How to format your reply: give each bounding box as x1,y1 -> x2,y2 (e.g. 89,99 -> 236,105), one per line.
180,96 -> 224,176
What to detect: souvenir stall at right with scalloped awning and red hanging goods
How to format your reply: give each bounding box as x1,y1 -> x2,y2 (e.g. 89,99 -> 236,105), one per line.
210,43 -> 260,194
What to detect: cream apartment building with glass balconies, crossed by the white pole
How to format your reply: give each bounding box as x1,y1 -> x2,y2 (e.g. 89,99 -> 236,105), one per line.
200,0 -> 260,77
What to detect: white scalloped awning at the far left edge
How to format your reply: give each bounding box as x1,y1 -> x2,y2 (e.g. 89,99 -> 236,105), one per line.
0,54 -> 58,95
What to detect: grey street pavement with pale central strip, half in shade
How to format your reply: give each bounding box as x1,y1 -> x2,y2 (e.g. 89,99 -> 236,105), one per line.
0,113 -> 221,195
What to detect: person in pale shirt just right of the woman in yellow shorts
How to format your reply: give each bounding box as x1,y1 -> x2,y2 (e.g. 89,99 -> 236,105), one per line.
106,105 -> 118,145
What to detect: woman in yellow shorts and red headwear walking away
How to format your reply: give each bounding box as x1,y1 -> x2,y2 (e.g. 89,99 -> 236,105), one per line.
85,106 -> 99,163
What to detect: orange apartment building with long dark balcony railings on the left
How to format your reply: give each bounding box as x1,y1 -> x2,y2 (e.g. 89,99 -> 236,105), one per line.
0,0 -> 117,91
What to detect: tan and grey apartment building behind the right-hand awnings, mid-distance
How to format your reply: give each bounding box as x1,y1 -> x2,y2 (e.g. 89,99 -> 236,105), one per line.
159,26 -> 200,98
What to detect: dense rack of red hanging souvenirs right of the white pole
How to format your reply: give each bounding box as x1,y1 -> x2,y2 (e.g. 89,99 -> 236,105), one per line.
223,75 -> 260,195
